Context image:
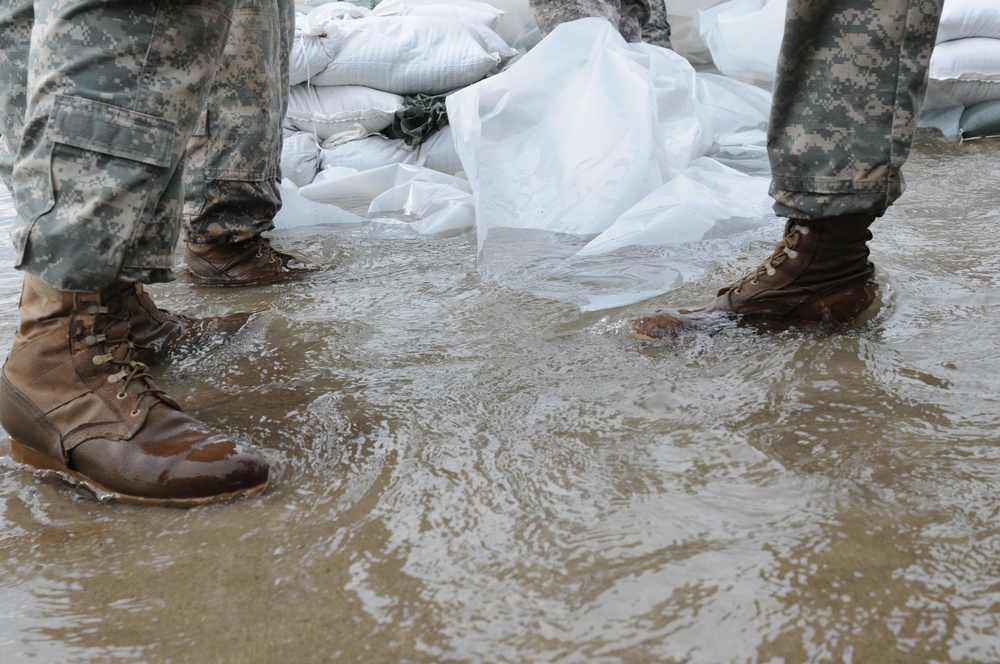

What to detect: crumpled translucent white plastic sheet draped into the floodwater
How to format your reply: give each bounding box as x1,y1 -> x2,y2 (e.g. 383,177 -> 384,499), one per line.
276,19 -> 774,310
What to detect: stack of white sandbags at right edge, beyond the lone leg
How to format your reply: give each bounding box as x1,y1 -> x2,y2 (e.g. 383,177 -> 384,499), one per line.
927,0 -> 1000,138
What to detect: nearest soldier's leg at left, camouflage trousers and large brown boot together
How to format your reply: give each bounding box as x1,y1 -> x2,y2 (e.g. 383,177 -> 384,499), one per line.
0,0 -> 268,506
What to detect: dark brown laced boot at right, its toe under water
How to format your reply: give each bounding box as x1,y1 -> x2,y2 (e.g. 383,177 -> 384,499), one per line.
633,215 -> 878,339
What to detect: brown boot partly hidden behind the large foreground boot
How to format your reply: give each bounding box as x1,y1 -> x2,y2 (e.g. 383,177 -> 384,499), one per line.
113,282 -> 253,365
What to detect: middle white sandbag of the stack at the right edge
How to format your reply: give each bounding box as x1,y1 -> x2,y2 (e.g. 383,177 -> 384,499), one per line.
928,37 -> 1000,106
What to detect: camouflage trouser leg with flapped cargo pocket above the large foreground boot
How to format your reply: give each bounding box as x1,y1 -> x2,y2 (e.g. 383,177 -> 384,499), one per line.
0,0 -> 236,291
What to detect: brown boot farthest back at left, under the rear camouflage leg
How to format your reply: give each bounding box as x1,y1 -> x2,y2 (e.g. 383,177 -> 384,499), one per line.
184,236 -> 319,286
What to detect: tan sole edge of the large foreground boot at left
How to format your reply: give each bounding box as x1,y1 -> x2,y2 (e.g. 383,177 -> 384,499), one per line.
8,438 -> 267,508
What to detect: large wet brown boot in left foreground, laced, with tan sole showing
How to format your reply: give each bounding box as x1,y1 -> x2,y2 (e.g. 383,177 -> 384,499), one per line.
0,275 -> 268,507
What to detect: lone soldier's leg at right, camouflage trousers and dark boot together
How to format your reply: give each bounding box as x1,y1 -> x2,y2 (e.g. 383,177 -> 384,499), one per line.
637,0 -> 942,337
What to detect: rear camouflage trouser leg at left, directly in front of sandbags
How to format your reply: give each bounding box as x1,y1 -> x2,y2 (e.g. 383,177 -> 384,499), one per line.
183,0 -> 295,244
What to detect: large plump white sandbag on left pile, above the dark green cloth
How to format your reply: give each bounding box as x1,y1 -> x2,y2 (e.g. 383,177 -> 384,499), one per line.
310,16 -> 502,95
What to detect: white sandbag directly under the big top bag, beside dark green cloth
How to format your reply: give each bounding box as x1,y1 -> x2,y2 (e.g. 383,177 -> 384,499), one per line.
285,83 -> 403,143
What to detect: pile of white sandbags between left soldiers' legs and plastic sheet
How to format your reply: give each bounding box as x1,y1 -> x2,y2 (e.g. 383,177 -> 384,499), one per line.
282,0 -> 518,186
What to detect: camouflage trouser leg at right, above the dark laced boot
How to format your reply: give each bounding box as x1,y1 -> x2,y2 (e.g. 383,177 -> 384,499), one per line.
768,0 -> 943,219
